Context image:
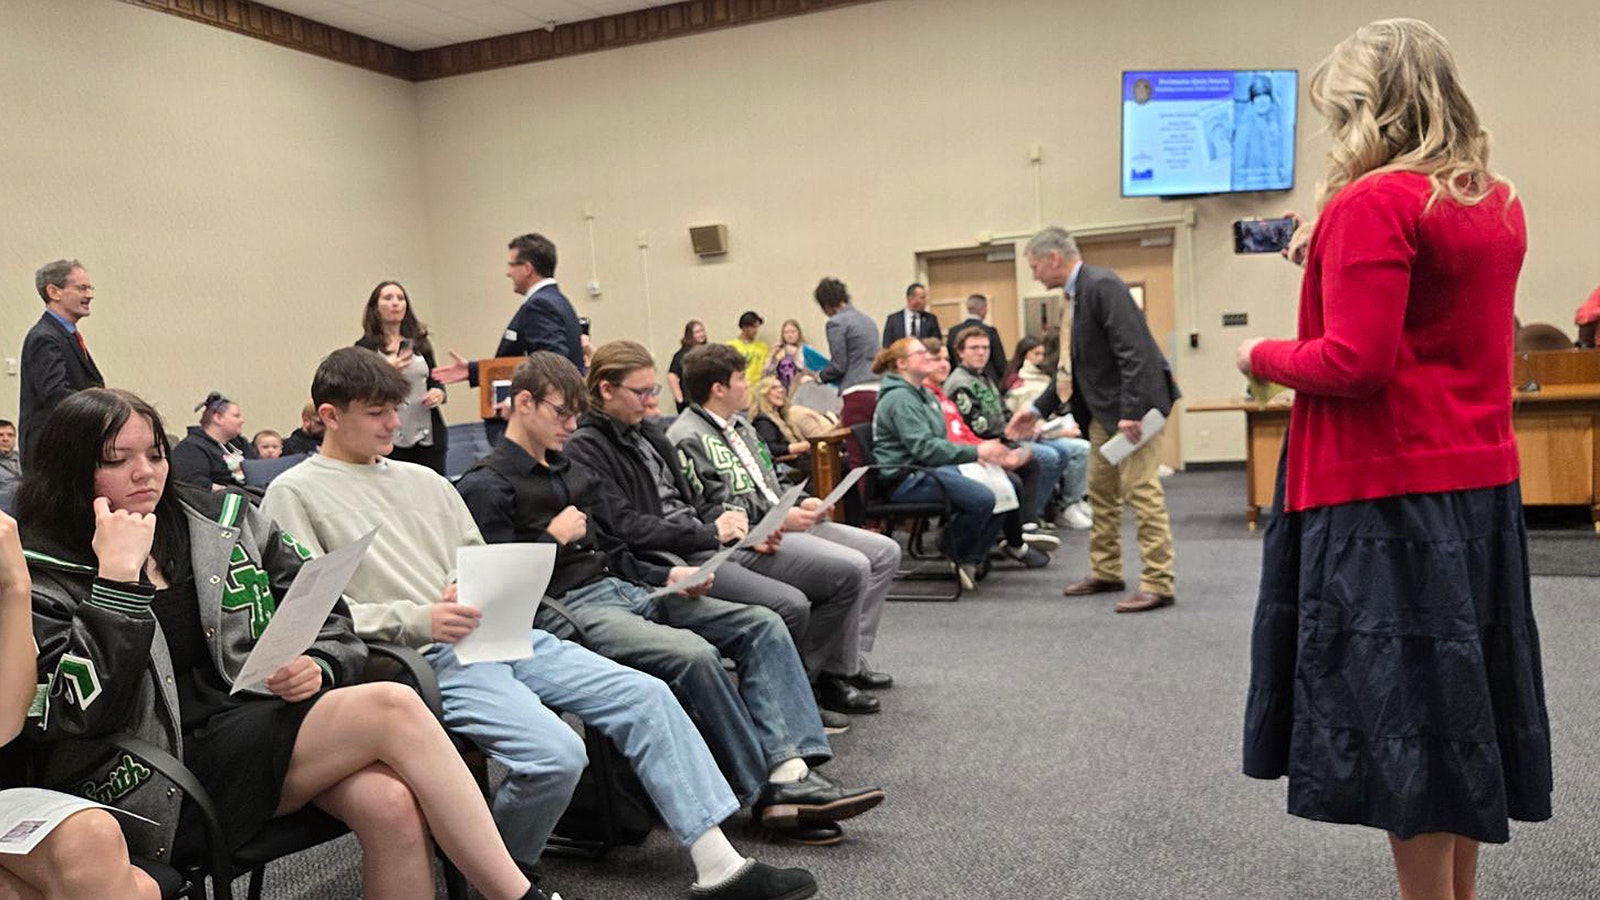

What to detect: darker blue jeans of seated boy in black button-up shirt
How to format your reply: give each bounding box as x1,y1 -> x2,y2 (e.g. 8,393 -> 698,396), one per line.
534,578 -> 834,804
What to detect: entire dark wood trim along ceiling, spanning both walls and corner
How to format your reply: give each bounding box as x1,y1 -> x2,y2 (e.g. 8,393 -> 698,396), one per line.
112,0 -> 872,82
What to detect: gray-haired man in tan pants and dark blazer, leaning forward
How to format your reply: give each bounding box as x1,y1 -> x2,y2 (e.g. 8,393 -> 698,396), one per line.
1008,227 -> 1178,612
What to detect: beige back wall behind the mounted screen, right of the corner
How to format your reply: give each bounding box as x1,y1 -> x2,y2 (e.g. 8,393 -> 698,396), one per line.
418,0 -> 1600,460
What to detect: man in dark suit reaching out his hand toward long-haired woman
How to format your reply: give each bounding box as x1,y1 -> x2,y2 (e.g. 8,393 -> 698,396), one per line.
432,234 -> 587,444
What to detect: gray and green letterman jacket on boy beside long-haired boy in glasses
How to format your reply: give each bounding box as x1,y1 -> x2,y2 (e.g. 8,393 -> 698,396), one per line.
667,404 -> 784,525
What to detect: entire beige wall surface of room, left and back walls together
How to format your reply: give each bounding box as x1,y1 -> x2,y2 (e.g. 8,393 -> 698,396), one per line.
0,0 -> 1600,460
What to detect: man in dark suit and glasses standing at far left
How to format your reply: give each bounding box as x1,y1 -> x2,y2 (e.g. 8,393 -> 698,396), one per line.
16,259 -> 106,460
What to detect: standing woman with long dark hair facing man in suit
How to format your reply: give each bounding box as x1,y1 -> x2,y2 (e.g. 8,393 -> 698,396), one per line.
355,282 -> 450,474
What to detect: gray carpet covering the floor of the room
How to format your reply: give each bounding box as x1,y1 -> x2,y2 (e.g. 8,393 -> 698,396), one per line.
236,471 -> 1600,900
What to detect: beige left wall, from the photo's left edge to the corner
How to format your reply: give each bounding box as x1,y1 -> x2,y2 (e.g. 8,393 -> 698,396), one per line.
0,0 -> 432,431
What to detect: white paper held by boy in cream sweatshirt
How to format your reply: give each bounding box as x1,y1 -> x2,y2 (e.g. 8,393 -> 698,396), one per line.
456,543 -> 555,665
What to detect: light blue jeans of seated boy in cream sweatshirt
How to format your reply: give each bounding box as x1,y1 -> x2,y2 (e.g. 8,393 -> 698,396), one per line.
426,629 -> 739,865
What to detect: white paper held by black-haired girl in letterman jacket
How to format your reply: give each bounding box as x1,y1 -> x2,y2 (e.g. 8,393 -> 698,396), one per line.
229,528 -> 378,693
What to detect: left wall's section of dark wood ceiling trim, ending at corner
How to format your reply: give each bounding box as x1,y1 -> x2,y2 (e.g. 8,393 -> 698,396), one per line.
122,0 -> 416,82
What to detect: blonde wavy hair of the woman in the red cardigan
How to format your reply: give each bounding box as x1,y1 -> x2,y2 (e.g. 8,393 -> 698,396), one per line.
1310,19 -> 1515,208
